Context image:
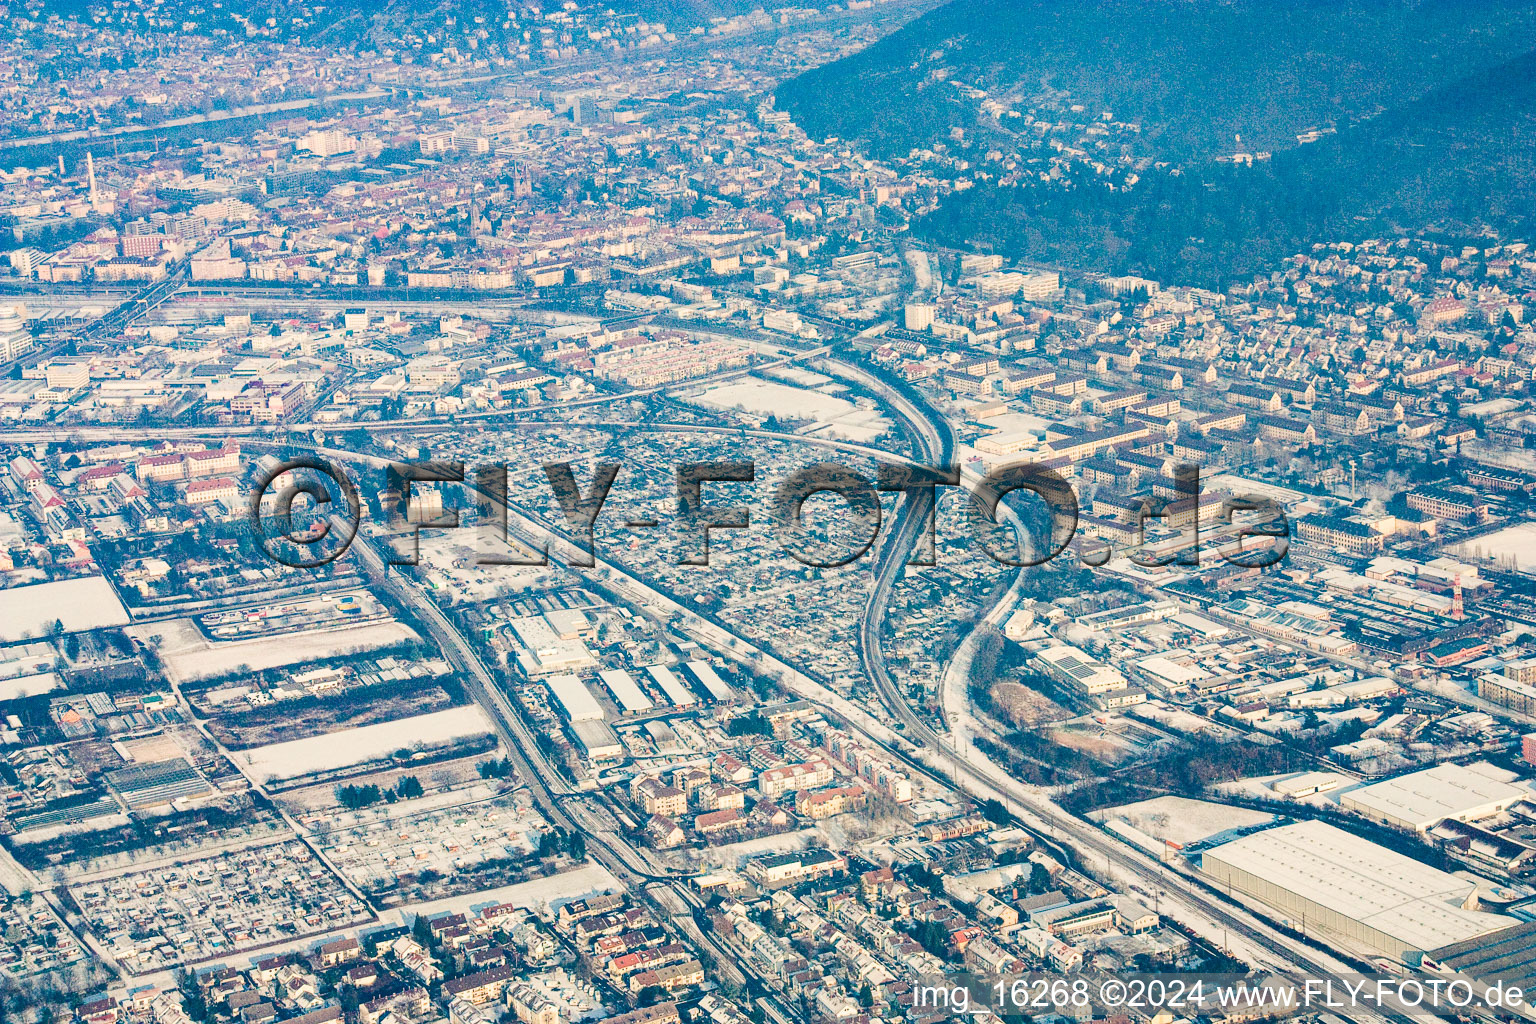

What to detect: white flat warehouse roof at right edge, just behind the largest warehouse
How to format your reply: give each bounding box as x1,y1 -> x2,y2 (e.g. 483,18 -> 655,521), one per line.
1339,761 -> 1531,831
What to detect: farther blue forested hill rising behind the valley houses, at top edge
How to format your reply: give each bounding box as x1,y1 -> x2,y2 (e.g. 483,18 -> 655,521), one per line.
776,0 -> 1536,161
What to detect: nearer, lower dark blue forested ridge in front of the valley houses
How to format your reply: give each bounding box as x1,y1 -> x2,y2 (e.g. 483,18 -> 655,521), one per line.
914,52 -> 1536,287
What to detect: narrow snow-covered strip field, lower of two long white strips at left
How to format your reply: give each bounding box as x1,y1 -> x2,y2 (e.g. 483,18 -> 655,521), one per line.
230,705 -> 495,780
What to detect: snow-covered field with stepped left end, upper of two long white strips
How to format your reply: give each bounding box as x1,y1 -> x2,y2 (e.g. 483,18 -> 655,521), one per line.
127,619 -> 418,683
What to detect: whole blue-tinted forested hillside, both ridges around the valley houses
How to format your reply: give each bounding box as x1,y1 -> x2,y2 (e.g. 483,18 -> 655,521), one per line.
776,0 -> 1536,286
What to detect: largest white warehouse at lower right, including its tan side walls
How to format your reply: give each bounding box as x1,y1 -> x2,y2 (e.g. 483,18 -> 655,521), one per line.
1201,821 -> 1518,961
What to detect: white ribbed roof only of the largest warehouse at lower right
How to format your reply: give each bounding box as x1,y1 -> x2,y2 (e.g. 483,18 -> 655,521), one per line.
1204,821 -> 1516,950
